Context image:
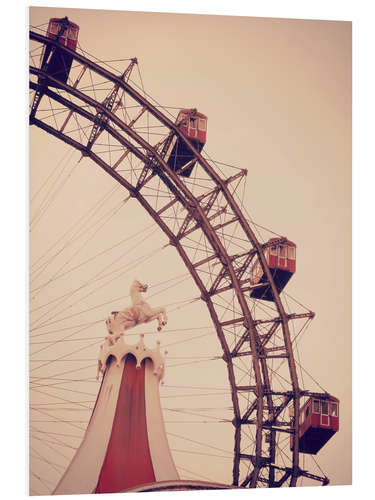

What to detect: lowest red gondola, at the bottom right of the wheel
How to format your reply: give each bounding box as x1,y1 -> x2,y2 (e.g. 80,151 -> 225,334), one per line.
290,395 -> 339,455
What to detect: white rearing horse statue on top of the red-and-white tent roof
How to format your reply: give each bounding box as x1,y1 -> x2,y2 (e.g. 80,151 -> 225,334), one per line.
106,280 -> 168,345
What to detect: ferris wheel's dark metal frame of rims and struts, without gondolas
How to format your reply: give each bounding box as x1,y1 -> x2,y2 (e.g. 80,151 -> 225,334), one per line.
30,27 -> 329,488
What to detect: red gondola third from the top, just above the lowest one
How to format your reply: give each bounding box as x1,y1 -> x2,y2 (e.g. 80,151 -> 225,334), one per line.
250,238 -> 296,301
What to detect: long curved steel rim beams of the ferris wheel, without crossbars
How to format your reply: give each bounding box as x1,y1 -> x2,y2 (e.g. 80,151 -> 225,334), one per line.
30,32 -> 306,487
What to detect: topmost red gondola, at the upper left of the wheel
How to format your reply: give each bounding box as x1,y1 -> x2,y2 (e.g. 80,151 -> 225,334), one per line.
40,17 -> 79,87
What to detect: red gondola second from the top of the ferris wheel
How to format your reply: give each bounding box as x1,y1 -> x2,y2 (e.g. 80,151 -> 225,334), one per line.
162,109 -> 207,177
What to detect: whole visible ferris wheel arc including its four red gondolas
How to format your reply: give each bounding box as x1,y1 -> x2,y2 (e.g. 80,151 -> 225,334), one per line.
30,18 -> 338,494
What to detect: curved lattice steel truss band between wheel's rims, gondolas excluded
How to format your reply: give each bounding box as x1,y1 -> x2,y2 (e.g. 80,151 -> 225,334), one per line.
30,31 -> 328,488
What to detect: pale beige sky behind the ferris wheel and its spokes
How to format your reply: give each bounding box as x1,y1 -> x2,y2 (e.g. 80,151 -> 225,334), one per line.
30,8 -> 352,498
